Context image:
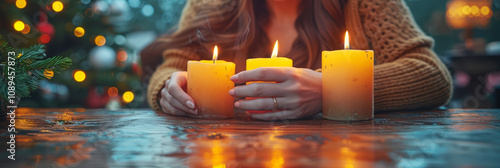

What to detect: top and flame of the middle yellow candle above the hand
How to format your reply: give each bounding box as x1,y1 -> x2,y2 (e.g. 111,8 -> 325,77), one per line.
247,40 -> 293,71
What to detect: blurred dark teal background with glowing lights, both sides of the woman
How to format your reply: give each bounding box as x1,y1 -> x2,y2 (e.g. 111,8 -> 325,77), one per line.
0,0 -> 500,109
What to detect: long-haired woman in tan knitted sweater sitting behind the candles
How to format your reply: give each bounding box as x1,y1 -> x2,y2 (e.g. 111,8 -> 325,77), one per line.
141,0 -> 452,120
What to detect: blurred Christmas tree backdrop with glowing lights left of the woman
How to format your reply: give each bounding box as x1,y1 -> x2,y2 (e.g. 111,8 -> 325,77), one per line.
0,0 -> 185,108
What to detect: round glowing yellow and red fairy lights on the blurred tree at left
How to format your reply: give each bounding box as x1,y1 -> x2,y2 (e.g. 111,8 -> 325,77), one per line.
13,0 -> 134,103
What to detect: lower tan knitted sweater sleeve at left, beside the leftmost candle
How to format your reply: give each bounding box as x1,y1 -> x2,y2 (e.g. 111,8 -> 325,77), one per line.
147,48 -> 200,111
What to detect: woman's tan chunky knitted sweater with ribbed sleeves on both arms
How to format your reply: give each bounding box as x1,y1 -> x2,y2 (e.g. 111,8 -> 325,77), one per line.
142,0 -> 452,111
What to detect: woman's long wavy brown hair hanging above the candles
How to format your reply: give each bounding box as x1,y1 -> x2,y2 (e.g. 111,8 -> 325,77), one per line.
142,0 -> 345,71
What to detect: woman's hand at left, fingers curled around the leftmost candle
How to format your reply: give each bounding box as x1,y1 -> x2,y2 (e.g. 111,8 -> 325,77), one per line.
160,71 -> 198,115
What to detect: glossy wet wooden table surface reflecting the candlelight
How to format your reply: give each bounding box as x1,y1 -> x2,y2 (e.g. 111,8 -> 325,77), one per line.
0,108 -> 500,168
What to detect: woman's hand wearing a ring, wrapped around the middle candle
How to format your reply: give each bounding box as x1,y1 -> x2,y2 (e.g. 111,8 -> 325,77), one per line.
229,67 -> 322,120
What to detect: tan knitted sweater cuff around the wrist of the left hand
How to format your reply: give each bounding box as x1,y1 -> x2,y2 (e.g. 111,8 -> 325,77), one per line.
148,68 -> 180,112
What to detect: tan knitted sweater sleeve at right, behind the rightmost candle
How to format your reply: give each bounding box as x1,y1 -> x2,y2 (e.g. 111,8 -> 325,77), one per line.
359,0 -> 452,111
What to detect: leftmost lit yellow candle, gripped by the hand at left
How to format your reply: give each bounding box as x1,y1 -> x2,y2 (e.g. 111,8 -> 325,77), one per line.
187,46 -> 235,119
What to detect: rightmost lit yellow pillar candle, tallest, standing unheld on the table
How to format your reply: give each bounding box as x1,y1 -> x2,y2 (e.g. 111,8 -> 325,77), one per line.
322,32 -> 373,121
